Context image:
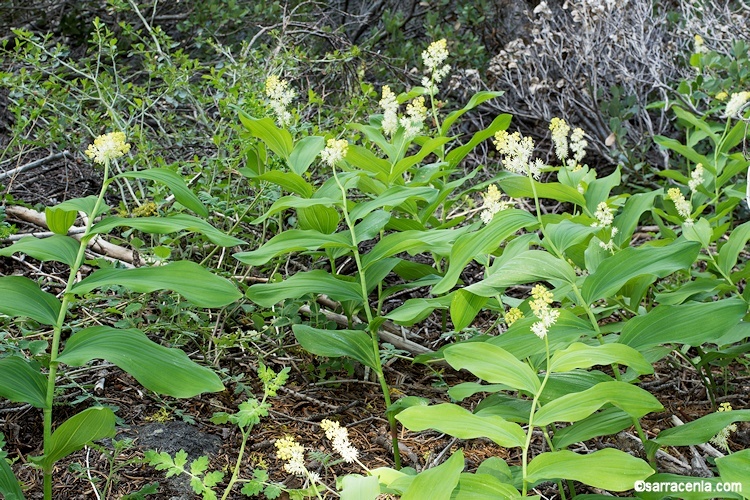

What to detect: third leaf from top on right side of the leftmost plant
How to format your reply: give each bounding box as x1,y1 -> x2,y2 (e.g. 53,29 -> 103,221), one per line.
71,261 -> 242,307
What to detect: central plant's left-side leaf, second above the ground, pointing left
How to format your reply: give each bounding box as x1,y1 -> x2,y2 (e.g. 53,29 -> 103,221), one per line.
245,269 -> 362,307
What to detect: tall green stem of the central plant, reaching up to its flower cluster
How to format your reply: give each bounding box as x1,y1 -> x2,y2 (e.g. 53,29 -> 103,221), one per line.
331,166 -> 401,470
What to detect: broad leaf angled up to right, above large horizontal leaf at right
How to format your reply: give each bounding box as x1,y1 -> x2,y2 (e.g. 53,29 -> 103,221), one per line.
581,240 -> 700,304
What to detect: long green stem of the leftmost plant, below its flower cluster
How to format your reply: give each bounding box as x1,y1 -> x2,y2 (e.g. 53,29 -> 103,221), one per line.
42,162 -> 109,500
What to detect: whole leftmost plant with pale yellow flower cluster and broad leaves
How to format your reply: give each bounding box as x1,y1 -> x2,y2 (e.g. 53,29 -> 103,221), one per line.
0,132 -> 241,499
